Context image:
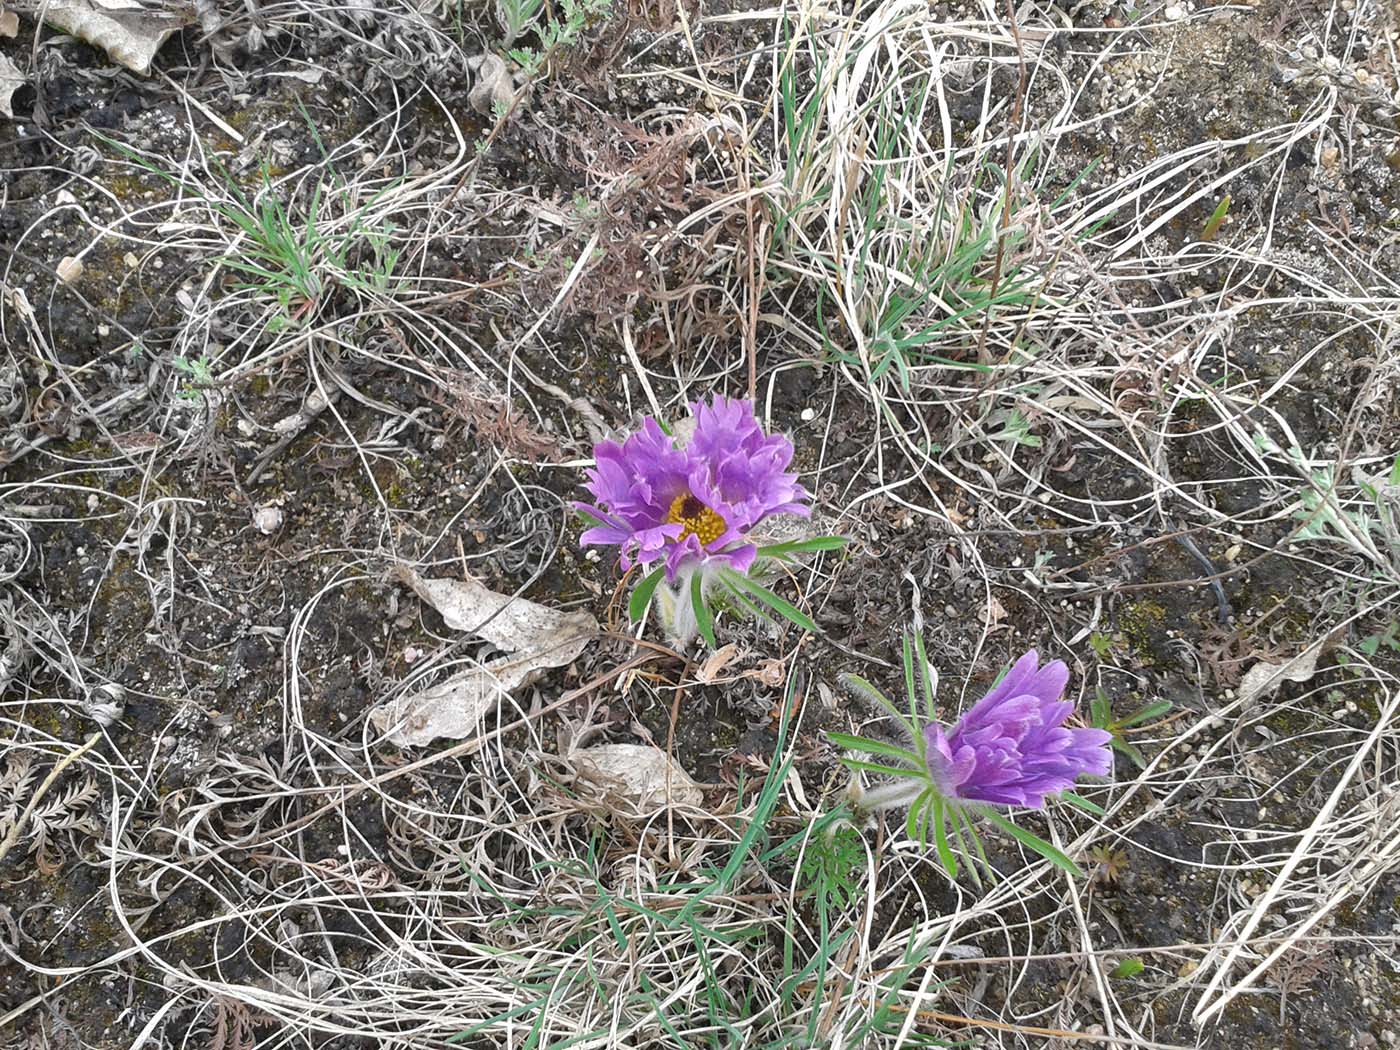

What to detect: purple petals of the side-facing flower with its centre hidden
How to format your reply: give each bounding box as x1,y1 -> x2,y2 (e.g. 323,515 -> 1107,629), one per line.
924,650 -> 1113,809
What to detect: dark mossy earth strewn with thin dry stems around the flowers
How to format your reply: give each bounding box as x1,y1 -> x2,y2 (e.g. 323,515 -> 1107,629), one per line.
0,0 -> 1400,1050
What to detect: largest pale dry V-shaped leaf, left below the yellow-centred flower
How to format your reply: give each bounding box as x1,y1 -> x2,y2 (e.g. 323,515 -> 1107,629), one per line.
370,566 -> 598,746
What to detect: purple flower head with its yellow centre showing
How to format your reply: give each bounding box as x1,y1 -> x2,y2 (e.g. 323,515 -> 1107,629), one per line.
574,396 -> 811,582
